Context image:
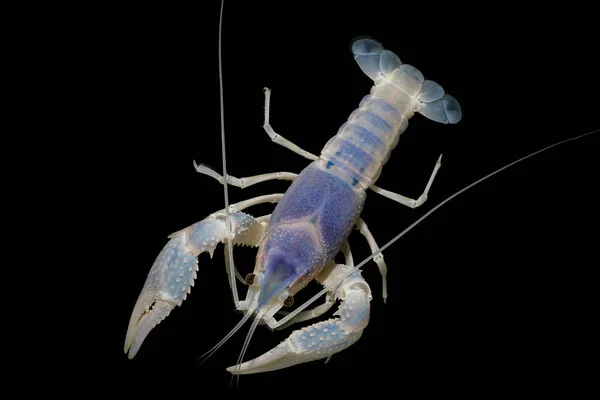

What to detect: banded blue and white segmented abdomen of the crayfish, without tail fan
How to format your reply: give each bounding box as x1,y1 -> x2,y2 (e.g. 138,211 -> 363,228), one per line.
320,77 -> 421,189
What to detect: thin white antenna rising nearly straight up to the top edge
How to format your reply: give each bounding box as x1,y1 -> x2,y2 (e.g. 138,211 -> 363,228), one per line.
219,0 -> 239,307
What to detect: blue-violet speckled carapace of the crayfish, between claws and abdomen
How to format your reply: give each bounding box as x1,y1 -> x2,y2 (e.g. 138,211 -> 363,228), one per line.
255,163 -> 366,305
